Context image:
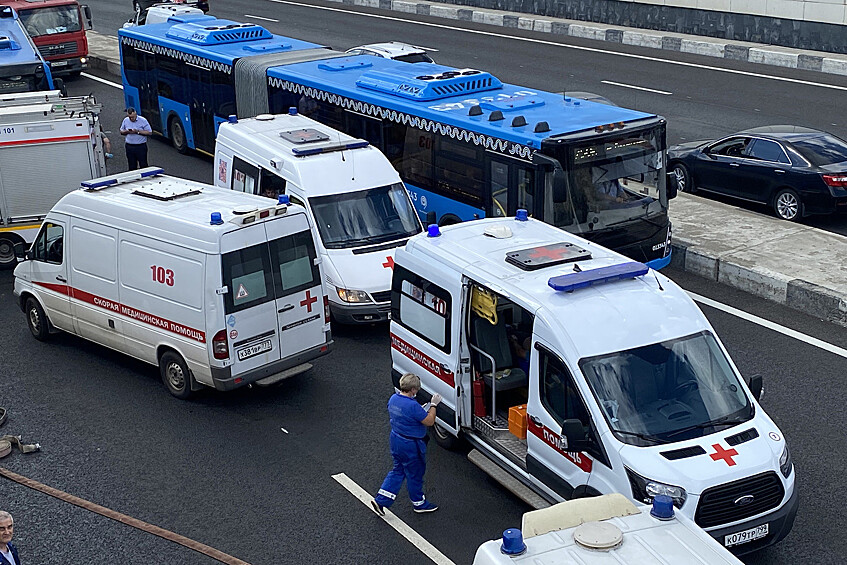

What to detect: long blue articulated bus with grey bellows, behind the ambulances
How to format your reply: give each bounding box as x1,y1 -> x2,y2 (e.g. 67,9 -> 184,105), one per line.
119,16 -> 674,268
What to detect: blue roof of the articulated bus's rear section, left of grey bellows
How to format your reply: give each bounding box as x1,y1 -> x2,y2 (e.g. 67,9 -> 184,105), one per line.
119,15 -> 323,65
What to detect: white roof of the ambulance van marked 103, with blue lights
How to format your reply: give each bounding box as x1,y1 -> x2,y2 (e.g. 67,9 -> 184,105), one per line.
48,167 -> 304,253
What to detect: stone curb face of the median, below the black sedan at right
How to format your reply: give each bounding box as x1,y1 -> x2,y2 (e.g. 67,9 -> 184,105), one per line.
671,239 -> 847,326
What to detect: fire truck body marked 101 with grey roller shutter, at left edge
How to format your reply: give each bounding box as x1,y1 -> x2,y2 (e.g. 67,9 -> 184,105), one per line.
0,90 -> 106,269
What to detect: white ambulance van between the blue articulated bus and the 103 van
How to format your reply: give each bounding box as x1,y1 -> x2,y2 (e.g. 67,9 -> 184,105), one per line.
215,108 -> 423,324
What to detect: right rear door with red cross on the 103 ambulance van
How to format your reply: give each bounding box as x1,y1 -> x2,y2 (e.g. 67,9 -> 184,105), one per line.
265,213 -> 326,359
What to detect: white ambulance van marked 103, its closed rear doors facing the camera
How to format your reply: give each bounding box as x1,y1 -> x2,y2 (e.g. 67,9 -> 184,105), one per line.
15,167 -> 332,398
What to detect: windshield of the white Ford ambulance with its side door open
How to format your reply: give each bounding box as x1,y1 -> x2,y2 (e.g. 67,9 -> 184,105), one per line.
579,332 -> 753,445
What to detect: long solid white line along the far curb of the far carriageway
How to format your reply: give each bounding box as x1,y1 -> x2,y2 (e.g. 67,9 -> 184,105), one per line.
268,0 -> 847,91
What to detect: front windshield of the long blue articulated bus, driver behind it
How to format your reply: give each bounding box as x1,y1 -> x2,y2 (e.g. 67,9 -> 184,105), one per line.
545,129 -> 667,233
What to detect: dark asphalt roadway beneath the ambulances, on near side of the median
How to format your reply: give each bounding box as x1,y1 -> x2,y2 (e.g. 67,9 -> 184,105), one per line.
0,79 -> 847,565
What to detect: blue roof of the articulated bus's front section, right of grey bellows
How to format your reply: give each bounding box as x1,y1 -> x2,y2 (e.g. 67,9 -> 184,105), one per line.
268,55 -> 656,148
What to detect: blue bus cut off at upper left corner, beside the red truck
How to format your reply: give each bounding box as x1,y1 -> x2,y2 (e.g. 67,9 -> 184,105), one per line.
0,6 -> 54,94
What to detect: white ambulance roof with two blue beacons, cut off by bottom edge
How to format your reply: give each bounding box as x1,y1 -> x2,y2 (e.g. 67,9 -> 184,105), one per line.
473,493 -> 742,565
